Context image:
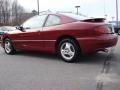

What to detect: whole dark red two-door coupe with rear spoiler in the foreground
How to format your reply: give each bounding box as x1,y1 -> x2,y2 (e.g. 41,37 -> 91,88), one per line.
2,13 -> 118,62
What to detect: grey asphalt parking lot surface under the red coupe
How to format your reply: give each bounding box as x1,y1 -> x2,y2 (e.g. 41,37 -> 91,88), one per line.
0,36 -> 120,90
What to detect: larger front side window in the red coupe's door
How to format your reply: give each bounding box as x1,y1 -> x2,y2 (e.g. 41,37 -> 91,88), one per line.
22,15 -> 47,29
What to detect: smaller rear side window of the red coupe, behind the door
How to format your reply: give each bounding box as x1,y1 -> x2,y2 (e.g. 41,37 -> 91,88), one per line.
45,15 -> 61,26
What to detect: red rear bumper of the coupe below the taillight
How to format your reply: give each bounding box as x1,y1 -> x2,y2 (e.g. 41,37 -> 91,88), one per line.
78,34 -> 118,54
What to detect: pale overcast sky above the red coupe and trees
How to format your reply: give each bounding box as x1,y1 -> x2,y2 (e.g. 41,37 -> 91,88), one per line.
18,0 -> 120,20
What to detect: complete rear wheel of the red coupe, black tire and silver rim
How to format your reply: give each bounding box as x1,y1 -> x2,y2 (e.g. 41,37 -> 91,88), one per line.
58,39 -> 80,62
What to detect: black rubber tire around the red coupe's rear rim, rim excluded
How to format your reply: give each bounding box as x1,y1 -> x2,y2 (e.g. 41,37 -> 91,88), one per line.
58,39 -> 80,62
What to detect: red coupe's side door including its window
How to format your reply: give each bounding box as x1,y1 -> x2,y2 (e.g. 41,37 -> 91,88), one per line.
16,15 -> 47,50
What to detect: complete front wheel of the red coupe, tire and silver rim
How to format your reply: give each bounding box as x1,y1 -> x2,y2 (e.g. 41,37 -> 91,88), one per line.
4,39 -> 15,55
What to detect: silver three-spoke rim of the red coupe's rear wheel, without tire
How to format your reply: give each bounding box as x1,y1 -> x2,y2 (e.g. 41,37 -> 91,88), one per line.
60,42 -> 75,61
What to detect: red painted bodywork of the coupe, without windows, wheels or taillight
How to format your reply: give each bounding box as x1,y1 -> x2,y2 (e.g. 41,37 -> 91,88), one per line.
2,14 -> 118,54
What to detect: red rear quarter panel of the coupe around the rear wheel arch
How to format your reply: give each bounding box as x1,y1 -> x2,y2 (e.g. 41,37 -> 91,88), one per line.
41,22 -> 101,52
